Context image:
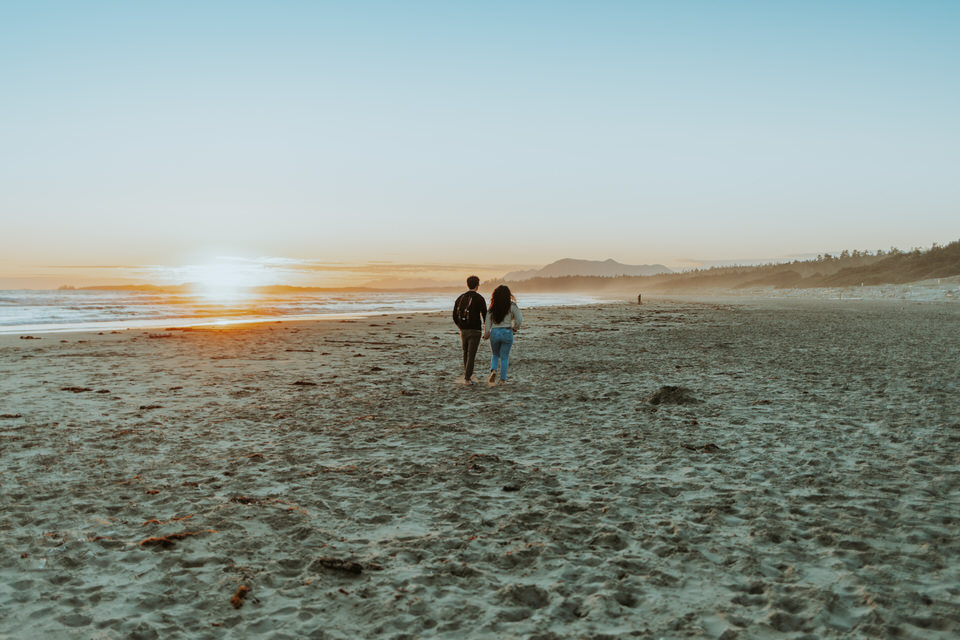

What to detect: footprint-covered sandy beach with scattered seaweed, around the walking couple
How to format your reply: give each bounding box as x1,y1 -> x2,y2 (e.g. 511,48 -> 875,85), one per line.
0,299 -> 960,639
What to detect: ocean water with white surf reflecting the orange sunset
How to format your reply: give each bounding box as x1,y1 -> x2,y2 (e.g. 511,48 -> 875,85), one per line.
0,290 -> 597,334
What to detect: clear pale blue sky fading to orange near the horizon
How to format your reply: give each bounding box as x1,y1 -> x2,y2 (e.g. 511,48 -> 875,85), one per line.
0,0 -> 960,287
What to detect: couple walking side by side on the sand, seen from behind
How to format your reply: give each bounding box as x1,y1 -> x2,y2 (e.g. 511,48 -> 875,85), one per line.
453,276 -> 523,385
